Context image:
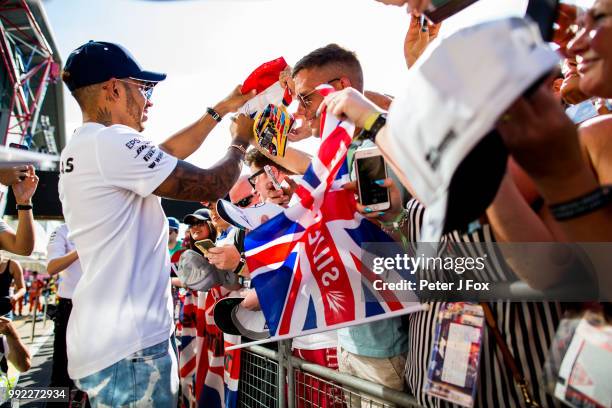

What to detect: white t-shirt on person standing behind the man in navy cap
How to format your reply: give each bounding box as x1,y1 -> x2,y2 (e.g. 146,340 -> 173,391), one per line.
47,224 -> 82,299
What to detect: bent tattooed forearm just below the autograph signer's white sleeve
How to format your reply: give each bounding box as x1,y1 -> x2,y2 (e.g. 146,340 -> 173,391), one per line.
153,149 -> 242,201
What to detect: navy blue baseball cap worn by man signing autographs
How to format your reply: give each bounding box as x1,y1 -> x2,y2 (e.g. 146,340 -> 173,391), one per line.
63,40 -> 166,91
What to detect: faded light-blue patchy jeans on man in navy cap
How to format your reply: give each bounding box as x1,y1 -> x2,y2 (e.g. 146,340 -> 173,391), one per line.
75,340 -> 179,408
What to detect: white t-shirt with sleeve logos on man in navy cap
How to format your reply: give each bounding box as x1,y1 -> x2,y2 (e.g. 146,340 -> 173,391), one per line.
59,123 -> 177,379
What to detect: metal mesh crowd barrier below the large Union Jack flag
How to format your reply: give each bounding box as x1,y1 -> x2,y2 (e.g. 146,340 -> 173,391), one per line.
238,341 -> 420,408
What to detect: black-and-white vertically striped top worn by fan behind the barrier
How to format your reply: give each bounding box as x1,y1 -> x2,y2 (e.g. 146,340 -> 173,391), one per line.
405,199 -> 561,408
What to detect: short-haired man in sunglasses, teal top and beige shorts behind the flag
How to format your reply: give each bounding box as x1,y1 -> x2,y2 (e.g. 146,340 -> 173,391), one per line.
292,44 -> 408,400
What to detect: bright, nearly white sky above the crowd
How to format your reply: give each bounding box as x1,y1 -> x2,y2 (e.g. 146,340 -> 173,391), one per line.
44,0 -> 526,166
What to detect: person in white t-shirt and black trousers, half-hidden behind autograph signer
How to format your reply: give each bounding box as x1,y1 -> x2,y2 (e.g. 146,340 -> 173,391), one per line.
47,224 -> 82,406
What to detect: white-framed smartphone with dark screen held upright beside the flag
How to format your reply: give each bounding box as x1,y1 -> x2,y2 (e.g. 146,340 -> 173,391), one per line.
355,147 -> 391,211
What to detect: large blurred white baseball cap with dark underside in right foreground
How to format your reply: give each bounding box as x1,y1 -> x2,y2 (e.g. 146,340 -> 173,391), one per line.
386,17 -> 559,242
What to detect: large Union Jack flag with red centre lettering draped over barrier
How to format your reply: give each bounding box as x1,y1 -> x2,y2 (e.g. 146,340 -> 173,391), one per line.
245,86 -> 422,341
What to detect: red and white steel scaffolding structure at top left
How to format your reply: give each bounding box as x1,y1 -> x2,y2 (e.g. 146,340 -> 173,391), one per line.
0,0 -> 60,154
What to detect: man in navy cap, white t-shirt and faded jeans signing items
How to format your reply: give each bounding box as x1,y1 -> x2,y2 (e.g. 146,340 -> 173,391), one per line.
59,41 -> 252,407
